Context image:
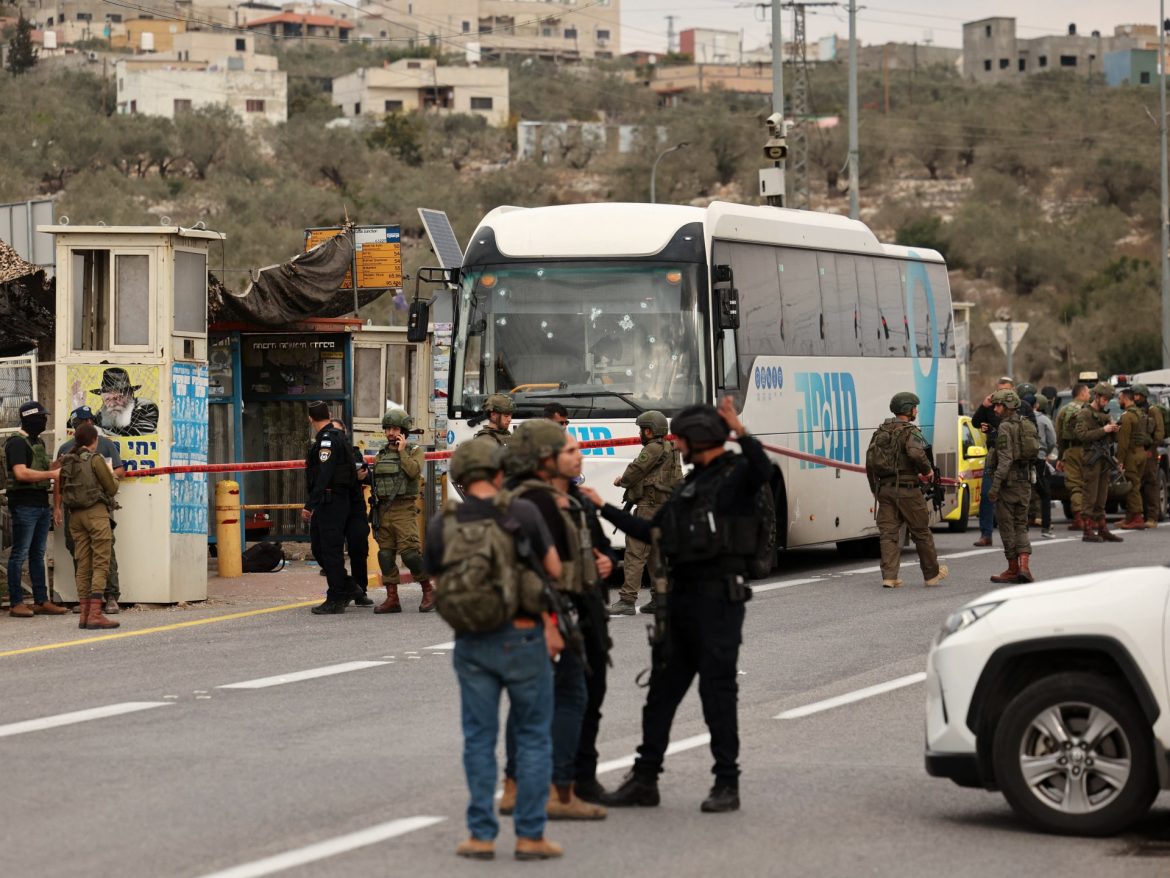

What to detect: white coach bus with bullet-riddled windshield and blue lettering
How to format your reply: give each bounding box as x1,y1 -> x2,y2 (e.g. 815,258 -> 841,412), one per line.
448,203 -> 958,559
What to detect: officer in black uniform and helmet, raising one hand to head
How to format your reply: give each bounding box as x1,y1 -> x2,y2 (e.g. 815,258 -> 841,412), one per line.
583,397 -> 772,812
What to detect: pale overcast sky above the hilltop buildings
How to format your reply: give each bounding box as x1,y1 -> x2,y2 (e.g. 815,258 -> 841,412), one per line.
620,0 -> 1170,52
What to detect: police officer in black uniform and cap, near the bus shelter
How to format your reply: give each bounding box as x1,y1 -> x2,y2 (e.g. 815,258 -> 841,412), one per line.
301,402 -> 369,616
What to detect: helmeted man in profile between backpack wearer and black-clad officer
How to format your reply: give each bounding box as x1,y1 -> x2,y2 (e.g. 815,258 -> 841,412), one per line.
500,418 -> 615,819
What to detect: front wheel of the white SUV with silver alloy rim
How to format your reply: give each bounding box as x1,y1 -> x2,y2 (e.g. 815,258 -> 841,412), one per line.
992,673 -> 1158,836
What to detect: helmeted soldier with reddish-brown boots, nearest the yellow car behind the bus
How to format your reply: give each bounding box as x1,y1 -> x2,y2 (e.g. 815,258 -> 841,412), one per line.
990,390 -> 1040,583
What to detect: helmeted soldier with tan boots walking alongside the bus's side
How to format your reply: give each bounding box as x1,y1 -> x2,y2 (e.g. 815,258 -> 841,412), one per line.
866,392 -> 948,589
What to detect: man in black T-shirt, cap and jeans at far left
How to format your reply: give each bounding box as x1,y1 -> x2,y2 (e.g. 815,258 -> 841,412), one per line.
4,400 -> 68,618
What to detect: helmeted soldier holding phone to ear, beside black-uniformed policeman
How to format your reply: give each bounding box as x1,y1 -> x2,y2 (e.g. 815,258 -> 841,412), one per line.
370,409 -> 435,612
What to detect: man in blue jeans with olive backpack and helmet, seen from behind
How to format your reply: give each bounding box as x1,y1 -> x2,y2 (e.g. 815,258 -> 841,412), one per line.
422,441 -> 564,859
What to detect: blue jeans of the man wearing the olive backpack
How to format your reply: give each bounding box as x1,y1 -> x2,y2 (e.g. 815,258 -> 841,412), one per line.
455,623 -> 552,841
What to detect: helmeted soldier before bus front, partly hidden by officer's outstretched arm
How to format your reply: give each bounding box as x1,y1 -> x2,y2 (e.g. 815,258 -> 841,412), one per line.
610,411 -> 682,616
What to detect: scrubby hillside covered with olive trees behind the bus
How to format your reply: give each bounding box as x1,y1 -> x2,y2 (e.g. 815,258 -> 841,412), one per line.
0,45 -> 1161,389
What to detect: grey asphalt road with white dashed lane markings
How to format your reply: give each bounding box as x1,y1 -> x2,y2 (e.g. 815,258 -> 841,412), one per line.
0,524 -> 1170,878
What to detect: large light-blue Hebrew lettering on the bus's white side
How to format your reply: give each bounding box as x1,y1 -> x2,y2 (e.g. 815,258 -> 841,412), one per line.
796,372 -> 861,469
